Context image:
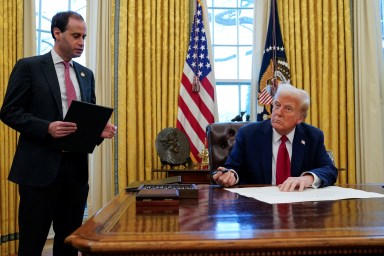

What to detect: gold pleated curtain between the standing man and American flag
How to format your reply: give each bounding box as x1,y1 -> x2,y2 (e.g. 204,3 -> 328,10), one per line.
112,0 -> 190,192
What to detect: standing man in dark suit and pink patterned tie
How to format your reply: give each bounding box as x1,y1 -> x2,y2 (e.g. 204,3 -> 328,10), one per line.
0,11 -> 116,256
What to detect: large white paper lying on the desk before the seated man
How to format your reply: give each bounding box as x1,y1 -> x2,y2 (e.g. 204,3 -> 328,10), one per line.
226,186 -> 384,204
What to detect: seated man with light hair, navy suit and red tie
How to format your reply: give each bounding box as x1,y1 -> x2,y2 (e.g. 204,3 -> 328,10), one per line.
213,84 -> 338,191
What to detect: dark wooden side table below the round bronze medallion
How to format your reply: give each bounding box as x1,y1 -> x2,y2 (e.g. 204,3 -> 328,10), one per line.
152,169 -> 210,184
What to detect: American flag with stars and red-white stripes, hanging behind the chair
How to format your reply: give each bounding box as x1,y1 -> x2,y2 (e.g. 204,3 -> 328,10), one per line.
176,0 -> 216,163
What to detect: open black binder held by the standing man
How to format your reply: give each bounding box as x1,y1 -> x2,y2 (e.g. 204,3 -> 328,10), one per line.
54,101 -> 113,153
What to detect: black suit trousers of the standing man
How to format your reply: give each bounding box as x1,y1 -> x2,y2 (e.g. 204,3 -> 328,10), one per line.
18,153 -> 89,256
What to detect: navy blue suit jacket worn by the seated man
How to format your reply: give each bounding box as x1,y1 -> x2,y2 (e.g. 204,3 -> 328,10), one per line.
225,120 -> 338,186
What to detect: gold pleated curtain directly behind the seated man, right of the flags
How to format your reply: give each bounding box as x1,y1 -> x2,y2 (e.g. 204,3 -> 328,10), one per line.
278,0 -> 356,183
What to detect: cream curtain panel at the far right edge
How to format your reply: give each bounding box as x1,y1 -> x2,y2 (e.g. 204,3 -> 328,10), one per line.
347,0 -> 384,183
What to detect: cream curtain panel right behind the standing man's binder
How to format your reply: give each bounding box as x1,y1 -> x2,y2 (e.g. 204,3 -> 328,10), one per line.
85,0 -> 115,217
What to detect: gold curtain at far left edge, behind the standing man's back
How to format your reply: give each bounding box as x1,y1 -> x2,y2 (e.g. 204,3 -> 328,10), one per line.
0,0 -> 23,255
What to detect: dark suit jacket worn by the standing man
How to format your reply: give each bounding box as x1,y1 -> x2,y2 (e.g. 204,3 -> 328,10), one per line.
0,52 -> 96,186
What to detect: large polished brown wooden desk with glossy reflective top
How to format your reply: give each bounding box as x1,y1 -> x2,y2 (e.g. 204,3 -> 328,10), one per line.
66,185 -> 384,256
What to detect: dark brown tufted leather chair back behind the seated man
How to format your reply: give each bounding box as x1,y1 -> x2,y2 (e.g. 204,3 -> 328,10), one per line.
206,122 -> 251,172
